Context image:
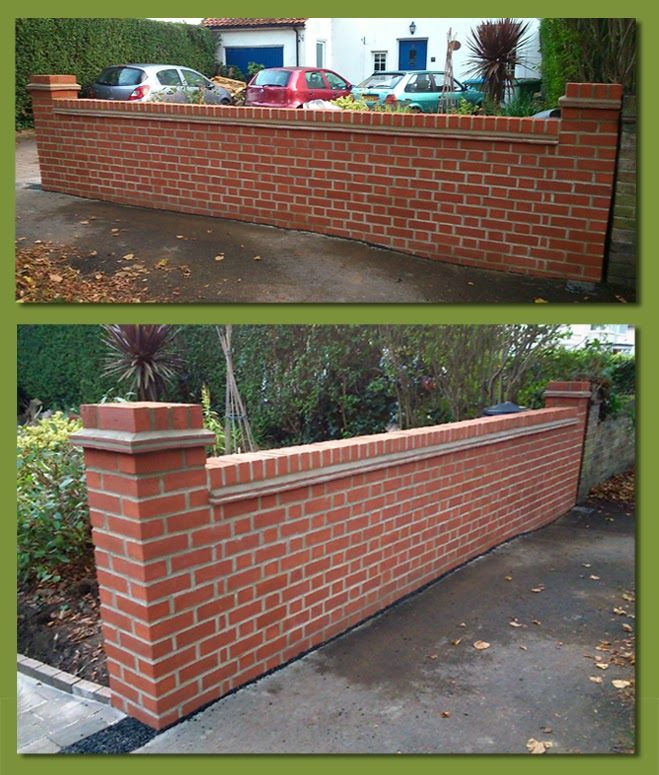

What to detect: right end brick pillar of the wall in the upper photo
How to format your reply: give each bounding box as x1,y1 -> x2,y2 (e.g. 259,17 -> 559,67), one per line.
555,83 -> 622,282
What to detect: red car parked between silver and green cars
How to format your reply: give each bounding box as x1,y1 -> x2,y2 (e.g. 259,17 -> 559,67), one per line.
245,67 -> 352,108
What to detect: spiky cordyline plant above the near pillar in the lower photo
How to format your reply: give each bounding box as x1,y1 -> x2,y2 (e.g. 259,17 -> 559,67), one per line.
103,325 -> 182,401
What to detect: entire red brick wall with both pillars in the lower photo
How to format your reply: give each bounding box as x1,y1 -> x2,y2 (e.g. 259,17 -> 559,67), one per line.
75,383 -> 589,728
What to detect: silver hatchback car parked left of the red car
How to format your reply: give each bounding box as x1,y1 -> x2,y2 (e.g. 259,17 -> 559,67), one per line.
89,65 -> 232,105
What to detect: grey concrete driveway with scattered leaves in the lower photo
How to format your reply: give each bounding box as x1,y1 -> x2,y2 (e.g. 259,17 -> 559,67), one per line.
131,504 -> 635,754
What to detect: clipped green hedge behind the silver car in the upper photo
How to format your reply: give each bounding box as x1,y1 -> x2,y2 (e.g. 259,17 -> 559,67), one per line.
16,19 -> 216,129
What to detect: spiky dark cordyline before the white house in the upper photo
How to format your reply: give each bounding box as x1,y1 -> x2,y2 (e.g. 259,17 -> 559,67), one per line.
467,19 -> 529,108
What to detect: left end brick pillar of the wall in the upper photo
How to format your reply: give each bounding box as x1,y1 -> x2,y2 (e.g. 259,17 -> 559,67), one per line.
27,75 -> 81,191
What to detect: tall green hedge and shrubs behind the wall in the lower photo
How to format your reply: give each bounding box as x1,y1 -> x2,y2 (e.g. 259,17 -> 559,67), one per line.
19,325 -> 635,448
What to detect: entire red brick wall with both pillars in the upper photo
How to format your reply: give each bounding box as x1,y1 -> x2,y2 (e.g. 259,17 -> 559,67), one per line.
29,76 -> 621,281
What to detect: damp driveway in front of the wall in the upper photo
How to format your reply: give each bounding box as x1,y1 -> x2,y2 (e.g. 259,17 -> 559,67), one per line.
16,134 -> 633,303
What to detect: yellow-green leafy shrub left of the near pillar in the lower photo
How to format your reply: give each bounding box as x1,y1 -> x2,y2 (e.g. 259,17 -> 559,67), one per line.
17,412 -> 90,584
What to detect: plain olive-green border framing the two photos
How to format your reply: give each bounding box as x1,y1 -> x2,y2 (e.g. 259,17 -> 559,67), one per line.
0,0 -> 659,775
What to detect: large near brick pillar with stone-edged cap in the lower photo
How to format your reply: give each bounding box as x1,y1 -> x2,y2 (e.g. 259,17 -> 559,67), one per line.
71,402 -> 217,729
